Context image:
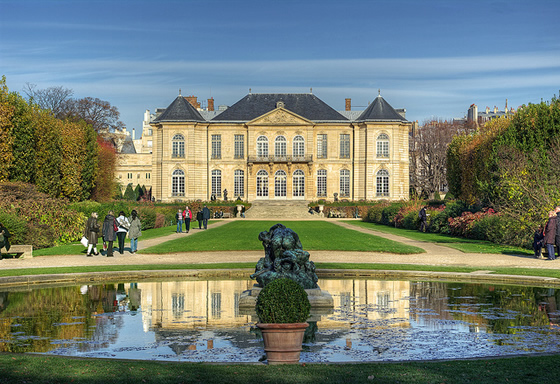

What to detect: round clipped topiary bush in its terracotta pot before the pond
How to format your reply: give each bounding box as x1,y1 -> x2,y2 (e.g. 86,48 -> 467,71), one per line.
256,278 -> 311,364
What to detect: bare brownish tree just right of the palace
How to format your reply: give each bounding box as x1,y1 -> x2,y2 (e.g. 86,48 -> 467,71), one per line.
410,120 -> 471,197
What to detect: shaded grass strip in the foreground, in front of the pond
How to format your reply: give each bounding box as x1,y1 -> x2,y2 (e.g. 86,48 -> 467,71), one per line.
0,354 -> 560,384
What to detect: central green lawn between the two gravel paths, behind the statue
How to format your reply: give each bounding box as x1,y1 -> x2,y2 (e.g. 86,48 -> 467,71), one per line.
140,220 -> 425,254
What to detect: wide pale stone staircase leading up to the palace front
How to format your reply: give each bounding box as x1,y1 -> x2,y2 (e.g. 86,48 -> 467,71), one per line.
245,200 -> 320,220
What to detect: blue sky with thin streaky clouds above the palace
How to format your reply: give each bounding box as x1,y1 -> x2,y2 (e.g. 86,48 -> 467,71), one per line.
0,0 -> 560,136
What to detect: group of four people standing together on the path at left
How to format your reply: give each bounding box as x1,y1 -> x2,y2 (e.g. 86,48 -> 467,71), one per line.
84,210 -> 142,257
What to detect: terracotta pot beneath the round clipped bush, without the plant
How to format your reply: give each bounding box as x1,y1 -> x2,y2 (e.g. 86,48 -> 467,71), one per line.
257,323 -> 309,365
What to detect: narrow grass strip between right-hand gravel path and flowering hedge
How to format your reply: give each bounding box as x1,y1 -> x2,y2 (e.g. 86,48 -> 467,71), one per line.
344,220 -> 533,255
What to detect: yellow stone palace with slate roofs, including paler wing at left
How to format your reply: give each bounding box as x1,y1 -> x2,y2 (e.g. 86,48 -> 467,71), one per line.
117,93 -> 412,202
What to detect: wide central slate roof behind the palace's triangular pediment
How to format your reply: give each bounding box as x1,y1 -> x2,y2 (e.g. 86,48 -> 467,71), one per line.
211,93 -> 348,122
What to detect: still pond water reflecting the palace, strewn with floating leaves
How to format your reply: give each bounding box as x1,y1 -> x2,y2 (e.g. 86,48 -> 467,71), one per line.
0,279 -> 560,362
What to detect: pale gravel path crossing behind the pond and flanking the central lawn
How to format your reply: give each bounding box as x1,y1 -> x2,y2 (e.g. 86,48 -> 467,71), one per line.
0,220 -> 560,270
